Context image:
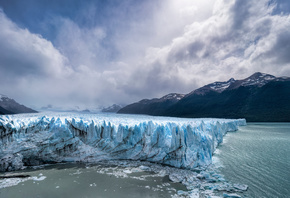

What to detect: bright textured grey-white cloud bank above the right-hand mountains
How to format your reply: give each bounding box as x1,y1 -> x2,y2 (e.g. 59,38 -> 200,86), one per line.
128,0 -> 290,94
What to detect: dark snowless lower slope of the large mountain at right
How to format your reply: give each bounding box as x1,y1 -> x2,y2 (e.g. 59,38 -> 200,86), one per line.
162,81 -> 290,122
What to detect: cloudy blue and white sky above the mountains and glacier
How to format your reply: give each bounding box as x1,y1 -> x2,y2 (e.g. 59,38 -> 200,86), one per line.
0,0 -> 290,109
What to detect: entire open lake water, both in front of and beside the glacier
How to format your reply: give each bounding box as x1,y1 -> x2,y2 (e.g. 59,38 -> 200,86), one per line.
0,123 -> 290,198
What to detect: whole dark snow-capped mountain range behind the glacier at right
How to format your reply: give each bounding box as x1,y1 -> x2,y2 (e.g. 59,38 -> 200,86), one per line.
118,72 -> 290,122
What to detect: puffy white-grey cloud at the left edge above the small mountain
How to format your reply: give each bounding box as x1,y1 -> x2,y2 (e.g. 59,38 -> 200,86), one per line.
0,10 -> 72,105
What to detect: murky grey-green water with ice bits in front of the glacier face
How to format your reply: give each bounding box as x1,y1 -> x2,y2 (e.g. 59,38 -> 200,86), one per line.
0,161 -> 186,198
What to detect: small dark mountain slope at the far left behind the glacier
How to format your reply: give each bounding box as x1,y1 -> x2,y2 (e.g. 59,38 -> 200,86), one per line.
0,94 -> 37,115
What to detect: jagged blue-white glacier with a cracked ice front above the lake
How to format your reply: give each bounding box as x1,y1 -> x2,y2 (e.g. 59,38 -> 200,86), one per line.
0,114 -> 246,171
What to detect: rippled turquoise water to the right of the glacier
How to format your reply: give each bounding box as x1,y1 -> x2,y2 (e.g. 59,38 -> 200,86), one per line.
217,123 -> 290,198
